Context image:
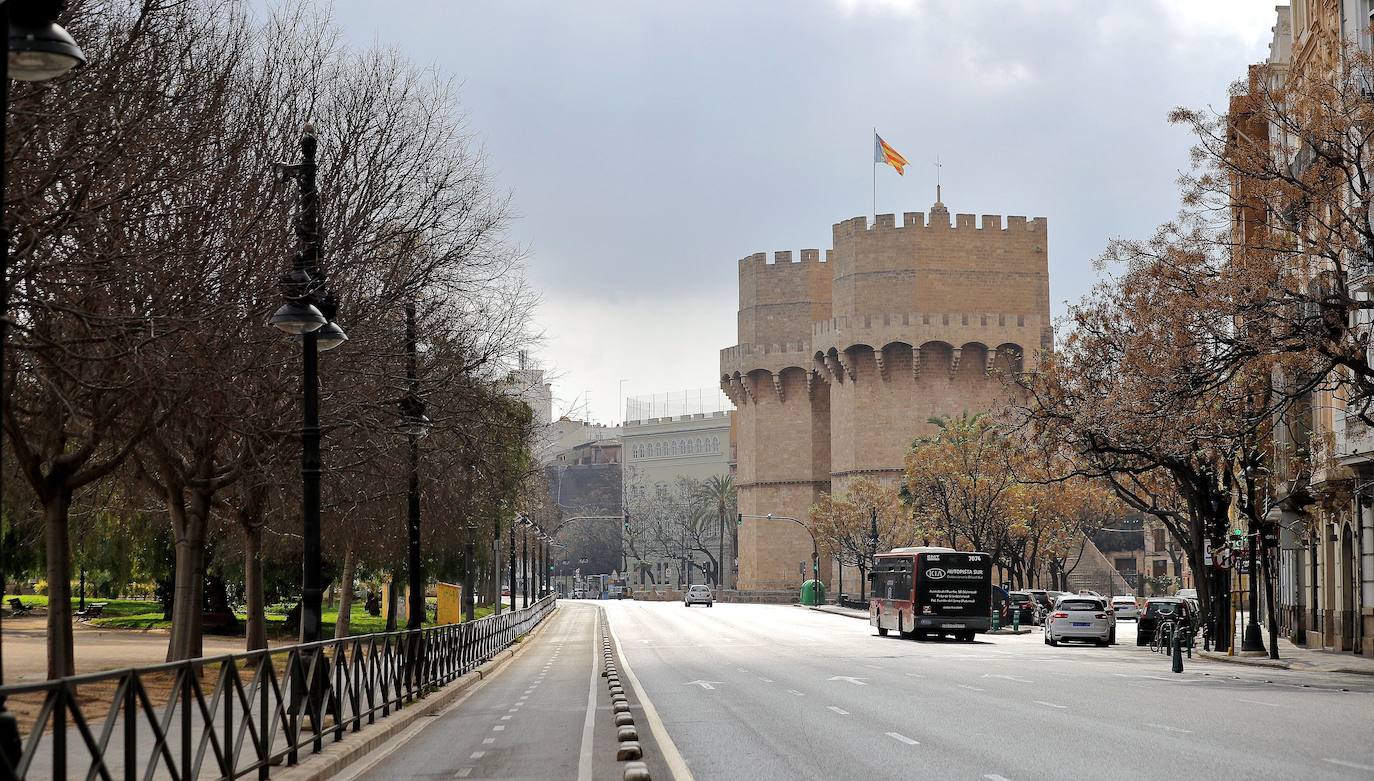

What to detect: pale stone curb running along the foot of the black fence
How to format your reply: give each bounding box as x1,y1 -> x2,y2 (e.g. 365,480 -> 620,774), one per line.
272,604 -> 558,781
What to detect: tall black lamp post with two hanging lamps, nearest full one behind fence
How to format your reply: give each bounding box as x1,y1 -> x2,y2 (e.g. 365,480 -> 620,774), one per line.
271,122 -> 348,642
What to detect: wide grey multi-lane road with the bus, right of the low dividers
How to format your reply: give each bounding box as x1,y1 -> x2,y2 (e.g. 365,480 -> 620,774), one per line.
607,601 -> 1374,781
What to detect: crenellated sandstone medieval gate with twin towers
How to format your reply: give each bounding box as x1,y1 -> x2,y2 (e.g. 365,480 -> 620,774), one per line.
720,193 -> 1052,590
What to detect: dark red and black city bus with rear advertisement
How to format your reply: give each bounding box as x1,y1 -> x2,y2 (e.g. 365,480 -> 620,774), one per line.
868,547 -> 992,642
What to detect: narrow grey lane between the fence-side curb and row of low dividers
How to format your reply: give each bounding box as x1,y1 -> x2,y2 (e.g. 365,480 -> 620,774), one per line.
341,601 -> 669,781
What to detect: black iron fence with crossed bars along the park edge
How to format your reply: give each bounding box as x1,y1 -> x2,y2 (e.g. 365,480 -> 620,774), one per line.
0,595 -> 554,781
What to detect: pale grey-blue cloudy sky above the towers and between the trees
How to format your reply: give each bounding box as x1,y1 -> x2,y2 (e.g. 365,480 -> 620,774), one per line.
334,0 -> 1274,422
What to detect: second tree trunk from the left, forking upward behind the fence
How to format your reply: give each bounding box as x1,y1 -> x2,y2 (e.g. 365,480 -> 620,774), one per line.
166,490 -> 210,661
